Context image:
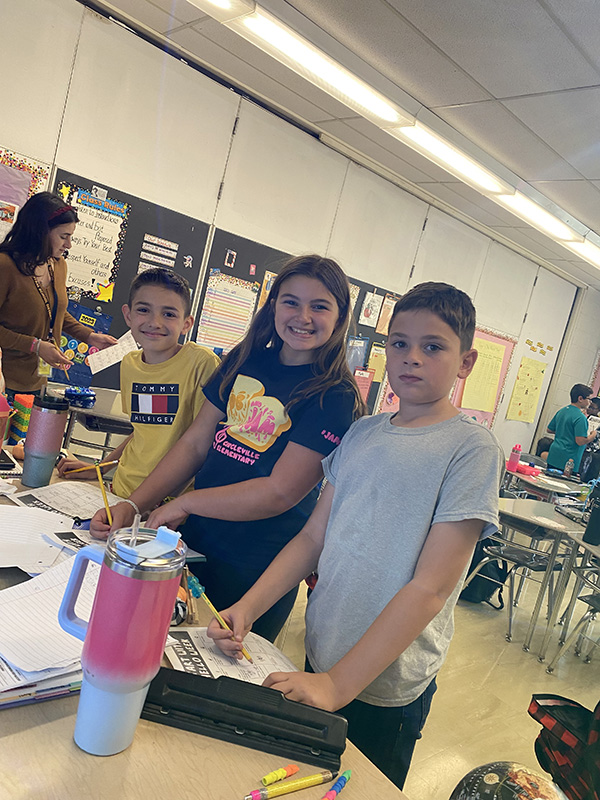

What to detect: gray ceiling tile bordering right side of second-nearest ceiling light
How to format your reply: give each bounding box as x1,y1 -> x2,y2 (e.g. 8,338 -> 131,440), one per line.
435,101 -> 581,181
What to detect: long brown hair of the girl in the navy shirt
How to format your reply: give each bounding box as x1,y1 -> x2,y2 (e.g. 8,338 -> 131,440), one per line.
219,255 -> 366,419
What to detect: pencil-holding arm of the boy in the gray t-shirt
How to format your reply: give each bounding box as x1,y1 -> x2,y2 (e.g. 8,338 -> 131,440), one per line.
207,483 -> 334,658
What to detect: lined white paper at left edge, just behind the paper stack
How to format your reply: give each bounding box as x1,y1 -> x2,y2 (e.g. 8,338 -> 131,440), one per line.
0,506 -> 73,572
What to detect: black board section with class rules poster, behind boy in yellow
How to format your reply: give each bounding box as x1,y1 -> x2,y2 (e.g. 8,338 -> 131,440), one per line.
54,169 -> 209,389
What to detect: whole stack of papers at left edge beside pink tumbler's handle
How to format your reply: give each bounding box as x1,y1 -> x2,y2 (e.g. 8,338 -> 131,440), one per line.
0,558 -> 100,708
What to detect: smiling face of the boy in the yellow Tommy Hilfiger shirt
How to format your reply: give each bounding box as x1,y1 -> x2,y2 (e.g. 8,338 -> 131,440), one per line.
122,286 -> 194,364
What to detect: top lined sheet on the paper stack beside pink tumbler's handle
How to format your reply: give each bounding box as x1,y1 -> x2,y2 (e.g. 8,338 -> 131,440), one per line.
0,558 -> 100,672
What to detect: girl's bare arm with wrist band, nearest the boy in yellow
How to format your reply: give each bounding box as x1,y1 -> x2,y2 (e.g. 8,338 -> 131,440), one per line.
90,400 -> 225,539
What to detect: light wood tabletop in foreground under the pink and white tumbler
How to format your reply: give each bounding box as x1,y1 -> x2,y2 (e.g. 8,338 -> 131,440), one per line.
0,478 -> 408,800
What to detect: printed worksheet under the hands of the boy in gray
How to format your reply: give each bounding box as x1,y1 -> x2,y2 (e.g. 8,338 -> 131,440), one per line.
165,627 -> 298,684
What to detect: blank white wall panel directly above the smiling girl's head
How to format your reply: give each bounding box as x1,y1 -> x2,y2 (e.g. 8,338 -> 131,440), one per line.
215,101 -> 348,254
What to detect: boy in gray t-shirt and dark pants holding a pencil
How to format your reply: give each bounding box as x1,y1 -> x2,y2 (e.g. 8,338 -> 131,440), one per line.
209,283 -> 504,788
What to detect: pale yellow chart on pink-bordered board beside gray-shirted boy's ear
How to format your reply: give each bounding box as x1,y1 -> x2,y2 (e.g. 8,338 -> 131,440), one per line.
450,328 -> 517,428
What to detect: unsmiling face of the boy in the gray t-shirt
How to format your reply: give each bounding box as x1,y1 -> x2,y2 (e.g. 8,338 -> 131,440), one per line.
386,309 -> 477,414
